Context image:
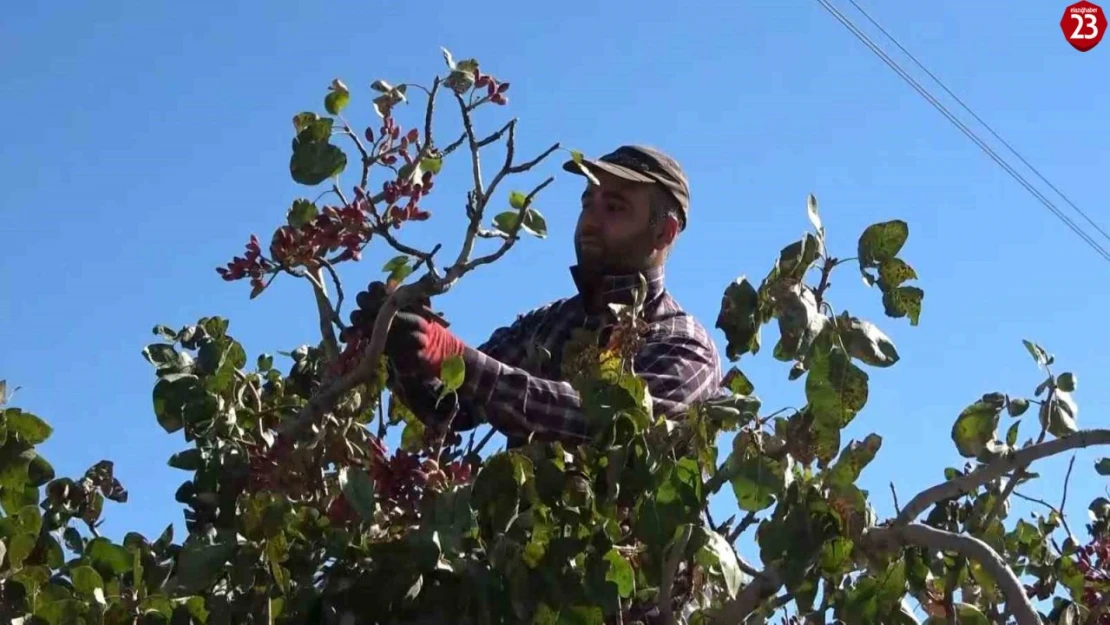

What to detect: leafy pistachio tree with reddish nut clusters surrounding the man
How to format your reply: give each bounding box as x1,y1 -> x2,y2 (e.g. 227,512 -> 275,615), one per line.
0,52 -> 1110,625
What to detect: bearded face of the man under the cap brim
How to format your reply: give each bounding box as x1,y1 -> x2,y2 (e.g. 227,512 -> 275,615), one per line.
574,172 -> 663,273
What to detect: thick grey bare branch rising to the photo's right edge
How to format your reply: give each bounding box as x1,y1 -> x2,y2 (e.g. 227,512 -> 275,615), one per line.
895,430 -> 1110,525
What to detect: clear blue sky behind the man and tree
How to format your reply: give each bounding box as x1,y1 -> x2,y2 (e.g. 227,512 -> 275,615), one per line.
0,0 -> 1110,568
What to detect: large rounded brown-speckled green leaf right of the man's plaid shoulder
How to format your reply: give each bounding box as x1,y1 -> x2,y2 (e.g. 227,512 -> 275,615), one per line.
806,349 -> 869,427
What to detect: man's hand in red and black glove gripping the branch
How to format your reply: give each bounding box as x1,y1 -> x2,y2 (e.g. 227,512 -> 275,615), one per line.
350,282 -> 466,377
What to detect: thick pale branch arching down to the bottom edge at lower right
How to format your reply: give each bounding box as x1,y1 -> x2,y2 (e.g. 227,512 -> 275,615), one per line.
861,528 -> 1038,625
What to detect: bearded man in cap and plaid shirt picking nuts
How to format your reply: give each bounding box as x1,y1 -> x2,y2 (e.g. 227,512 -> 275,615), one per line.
351,145 -> 722,446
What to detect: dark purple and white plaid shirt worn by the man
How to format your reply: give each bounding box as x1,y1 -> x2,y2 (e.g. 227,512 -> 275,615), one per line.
395,268 -> 722,445
